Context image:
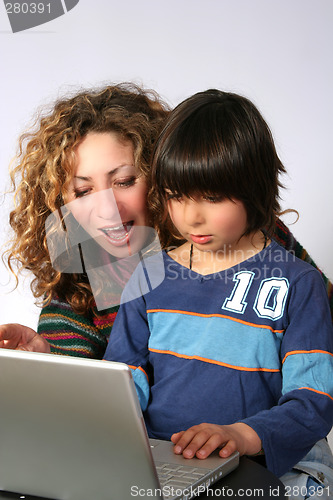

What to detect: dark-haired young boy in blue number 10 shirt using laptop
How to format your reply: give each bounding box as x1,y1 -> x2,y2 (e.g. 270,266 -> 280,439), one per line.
105,90 -> 333,494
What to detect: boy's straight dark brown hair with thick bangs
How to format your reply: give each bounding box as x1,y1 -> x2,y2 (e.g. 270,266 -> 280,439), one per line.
149,89 -> 285,246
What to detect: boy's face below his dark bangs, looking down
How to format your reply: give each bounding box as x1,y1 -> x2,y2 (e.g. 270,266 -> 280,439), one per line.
167,194 -> 247,252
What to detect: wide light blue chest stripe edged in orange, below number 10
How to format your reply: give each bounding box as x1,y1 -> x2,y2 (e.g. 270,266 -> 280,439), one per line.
148,311 -> 283,370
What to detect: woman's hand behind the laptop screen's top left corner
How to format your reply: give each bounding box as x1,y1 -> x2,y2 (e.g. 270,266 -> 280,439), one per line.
0,323 -> 51,353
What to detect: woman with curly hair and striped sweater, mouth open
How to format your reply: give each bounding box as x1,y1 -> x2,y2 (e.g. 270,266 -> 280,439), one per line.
0,84 -> 333,358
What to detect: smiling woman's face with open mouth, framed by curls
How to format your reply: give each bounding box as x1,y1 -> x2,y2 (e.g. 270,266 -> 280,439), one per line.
66,133 -> 147,258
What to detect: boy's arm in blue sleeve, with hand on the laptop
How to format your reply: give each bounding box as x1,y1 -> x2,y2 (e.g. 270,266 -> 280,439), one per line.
172,271 -> 333,476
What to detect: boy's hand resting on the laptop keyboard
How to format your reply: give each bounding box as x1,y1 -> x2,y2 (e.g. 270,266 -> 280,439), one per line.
171,422 -> 261,458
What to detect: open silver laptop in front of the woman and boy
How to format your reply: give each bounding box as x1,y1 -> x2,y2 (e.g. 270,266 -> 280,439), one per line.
0,349 -> 239,500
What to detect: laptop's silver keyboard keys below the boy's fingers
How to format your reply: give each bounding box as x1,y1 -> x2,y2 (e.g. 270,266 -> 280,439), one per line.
155,462 -> 210,500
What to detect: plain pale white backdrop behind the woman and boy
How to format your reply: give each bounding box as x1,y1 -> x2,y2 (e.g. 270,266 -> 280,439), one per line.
0,0 -> 333,327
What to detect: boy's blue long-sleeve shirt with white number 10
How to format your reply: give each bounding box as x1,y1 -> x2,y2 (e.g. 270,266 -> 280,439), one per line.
105,242 -> 333,476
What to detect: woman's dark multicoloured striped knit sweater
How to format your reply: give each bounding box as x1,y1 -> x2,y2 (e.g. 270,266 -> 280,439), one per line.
37,220 -> 333,359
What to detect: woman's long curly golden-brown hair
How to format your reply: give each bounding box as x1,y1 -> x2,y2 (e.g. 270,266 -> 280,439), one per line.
5,83 -> 169,314
